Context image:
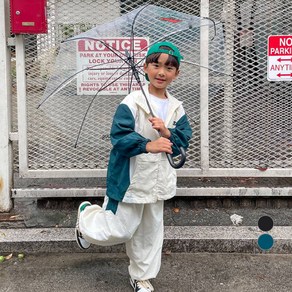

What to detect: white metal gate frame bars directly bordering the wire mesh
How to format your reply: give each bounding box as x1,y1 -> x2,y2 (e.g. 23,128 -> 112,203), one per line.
15,0 -> 292,178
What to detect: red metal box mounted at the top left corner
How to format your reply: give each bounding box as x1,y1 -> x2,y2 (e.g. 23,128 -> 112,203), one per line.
10,0 -> 48,34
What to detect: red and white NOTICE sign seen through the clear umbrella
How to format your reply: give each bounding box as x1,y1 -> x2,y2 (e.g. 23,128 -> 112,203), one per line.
77,38 -> 149,95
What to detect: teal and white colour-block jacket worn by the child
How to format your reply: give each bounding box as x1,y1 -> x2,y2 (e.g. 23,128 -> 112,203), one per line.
107,86 -> 192,203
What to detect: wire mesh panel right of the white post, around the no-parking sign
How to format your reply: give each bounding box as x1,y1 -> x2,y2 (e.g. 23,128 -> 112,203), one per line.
210,0 -> 292,170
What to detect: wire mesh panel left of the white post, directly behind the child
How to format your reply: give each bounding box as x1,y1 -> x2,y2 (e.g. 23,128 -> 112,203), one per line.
21,0 -> 213,170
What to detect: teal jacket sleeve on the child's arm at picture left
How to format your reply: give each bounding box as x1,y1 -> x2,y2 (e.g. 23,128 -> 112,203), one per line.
110,104 -> 151,157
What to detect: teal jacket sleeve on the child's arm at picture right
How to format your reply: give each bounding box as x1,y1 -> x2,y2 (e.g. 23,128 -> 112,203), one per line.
169,114 -> 192,156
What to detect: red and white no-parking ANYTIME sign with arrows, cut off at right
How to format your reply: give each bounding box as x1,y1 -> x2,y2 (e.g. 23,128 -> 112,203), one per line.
267,35 -> 292,81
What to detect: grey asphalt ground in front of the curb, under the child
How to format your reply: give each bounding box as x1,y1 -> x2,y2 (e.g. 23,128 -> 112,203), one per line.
0,253 -> 292,292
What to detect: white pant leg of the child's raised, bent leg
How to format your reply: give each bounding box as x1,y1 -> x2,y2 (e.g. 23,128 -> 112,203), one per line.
79,197 -> 143,246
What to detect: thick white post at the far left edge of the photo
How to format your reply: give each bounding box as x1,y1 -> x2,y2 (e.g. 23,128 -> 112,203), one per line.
0,0 -> 13,212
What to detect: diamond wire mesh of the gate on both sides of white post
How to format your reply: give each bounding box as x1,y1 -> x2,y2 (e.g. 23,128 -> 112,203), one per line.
15,0 -> 292,176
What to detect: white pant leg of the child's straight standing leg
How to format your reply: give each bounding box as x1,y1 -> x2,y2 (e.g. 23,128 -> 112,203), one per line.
126,201 -> 164,280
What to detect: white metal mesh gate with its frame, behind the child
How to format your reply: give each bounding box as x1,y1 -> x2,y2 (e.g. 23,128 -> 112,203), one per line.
12,0 -> 292,195
